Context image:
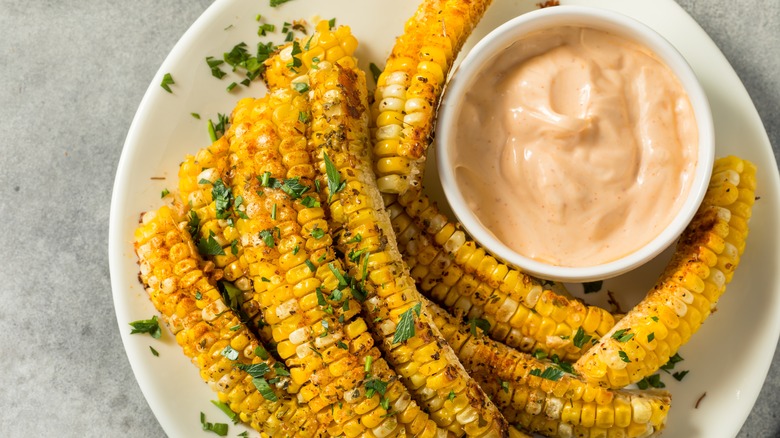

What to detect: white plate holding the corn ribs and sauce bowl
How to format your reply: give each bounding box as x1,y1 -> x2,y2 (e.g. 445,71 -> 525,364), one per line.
109,0 -> 780,438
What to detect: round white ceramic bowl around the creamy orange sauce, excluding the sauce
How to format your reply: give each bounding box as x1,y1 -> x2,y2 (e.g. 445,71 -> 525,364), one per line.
436,6 -> 715,282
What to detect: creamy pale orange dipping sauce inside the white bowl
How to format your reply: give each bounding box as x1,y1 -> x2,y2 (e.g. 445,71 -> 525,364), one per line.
451,27 -> 698,267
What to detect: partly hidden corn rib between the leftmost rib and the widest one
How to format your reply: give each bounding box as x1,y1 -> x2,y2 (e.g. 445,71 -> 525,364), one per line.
179,136 -> 270,341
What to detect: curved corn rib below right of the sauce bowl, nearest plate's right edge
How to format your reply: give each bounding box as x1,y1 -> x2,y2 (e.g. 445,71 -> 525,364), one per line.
575,156 -> 756,388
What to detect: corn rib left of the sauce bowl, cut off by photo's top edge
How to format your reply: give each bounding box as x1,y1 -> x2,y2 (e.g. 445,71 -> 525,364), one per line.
371,0 -> 490,193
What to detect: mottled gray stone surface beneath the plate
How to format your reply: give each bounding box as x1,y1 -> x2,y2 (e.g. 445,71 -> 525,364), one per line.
0,0 -> 780,437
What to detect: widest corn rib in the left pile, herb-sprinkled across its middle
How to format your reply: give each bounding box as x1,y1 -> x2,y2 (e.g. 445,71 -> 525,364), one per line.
226,80 -> 437,437
